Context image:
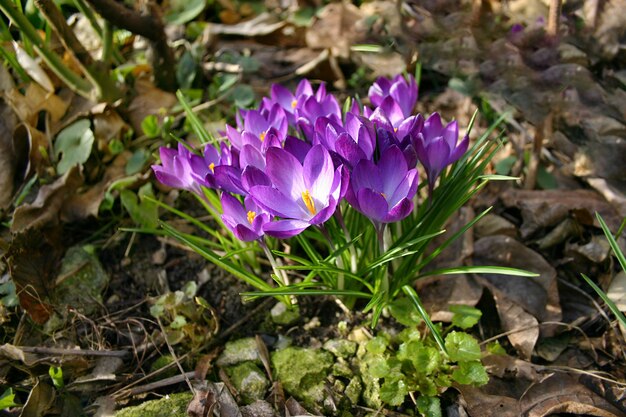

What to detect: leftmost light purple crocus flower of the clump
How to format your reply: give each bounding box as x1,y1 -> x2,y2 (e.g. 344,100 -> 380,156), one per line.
152,143 -> 206,195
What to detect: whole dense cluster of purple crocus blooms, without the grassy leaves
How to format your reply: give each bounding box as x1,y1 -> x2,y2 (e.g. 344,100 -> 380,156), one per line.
153,75 -> 468,243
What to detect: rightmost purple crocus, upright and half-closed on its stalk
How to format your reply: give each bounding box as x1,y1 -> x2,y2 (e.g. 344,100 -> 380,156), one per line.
414,113 -> 469,192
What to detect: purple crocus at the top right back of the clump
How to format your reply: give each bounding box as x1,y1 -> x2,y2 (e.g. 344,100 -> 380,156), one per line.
368,74 -> 417,118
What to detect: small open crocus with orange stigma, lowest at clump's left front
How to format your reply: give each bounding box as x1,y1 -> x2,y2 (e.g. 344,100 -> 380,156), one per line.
221,193 -> 271,242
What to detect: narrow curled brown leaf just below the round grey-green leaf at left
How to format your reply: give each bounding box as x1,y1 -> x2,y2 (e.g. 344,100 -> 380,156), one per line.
11,166 -> 83,233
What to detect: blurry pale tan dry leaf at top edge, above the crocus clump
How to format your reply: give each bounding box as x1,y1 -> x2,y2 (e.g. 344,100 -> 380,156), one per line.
305,2 -> 363,58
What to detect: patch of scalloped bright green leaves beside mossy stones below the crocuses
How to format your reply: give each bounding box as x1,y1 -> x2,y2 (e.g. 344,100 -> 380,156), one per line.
361,328 -> 489,410
